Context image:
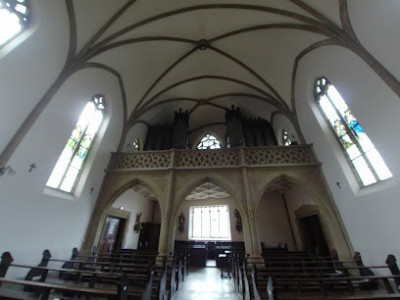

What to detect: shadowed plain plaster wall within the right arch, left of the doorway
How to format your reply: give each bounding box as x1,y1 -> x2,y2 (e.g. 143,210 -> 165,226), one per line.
256,193 -> 294,250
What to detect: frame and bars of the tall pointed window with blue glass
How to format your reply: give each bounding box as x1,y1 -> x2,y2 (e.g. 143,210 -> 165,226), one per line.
314,76 -> 393,187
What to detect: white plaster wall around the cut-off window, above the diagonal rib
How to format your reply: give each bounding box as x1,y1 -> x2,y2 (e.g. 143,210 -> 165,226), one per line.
0,0 -> 68,151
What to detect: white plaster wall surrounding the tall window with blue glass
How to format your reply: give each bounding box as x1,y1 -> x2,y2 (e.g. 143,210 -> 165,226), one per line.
295,43 -> 400,263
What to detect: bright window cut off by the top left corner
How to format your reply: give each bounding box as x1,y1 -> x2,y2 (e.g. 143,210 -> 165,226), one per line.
0,0 -> 30,47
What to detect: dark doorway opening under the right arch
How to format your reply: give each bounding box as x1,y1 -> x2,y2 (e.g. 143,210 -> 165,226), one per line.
299,215 -> 330,256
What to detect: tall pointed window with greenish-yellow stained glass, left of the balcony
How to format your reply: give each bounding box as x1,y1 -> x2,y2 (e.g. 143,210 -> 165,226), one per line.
46,95 -> 105,192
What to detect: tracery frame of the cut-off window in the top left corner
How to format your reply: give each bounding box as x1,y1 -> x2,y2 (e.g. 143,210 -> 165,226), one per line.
0,0 -> 31,49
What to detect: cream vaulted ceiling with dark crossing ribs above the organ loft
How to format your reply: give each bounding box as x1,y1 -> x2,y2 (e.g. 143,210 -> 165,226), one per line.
50,0 -> 378,148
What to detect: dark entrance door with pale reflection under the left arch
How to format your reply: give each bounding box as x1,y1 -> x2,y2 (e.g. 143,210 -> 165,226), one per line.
99,216 -> 126,254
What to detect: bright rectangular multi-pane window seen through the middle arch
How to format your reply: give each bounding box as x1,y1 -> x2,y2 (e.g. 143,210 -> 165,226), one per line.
189,205 -> 231,240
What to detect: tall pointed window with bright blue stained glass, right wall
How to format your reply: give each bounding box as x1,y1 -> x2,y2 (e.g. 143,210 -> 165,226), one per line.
315,77 -> 392,186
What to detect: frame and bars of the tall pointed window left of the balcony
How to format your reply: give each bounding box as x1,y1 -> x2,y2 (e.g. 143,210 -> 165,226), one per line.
46,94 -> 106,194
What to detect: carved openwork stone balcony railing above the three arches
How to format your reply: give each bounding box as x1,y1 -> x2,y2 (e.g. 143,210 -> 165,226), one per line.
109,145 -> 318,170
